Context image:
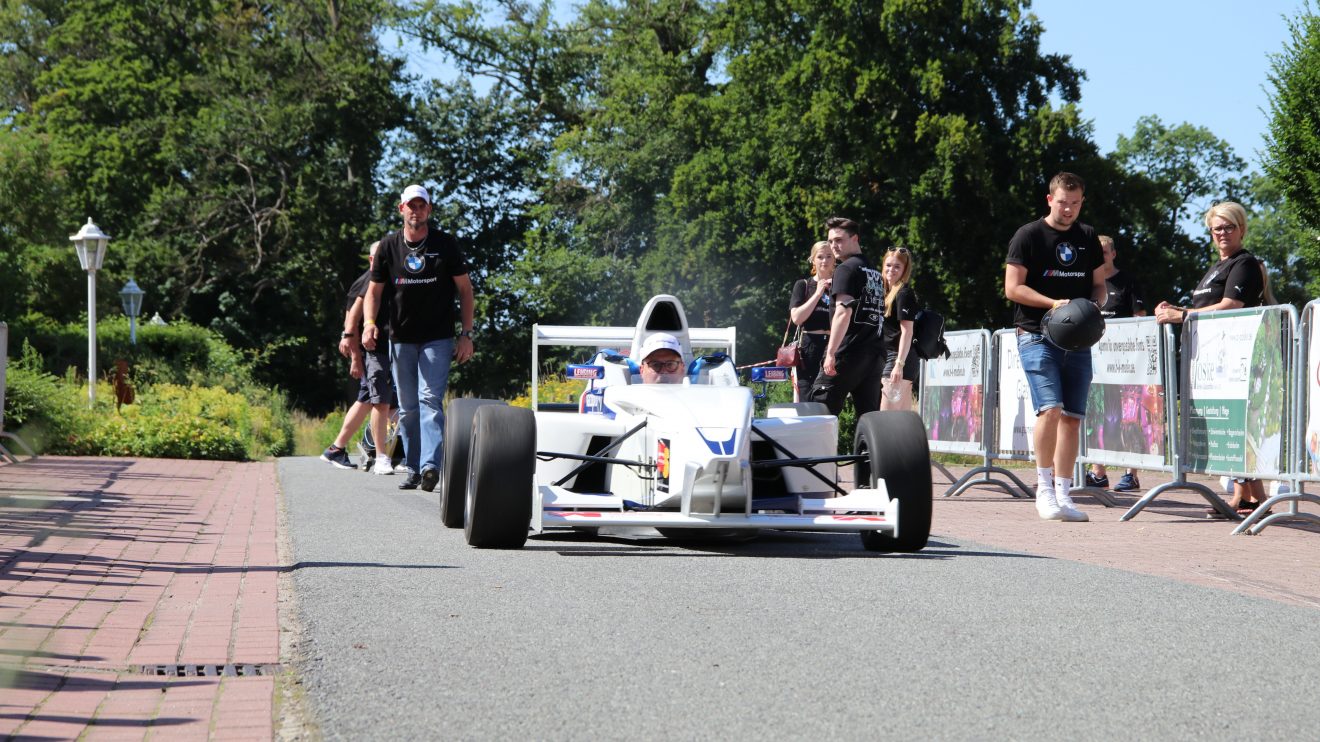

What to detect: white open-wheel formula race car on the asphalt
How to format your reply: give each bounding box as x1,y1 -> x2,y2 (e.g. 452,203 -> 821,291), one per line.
441,294 -> 931,552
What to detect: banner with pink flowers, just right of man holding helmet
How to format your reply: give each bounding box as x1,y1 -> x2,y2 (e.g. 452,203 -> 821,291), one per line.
1085,320 -> 1168,469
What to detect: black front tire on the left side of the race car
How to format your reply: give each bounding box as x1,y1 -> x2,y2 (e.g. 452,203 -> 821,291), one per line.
463,405 -> 536,549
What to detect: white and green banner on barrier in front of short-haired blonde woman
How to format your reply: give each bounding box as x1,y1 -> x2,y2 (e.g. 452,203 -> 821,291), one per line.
1183,312 -> 1288,478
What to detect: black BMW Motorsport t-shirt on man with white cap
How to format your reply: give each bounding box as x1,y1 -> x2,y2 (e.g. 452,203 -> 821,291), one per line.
371,227 -> 467,343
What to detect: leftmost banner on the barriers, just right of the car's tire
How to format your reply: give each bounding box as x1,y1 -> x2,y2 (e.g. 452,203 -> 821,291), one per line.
921,331 -> 987,454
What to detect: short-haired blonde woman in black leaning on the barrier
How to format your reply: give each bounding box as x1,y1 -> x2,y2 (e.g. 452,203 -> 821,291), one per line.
1155,201 -> 1274,518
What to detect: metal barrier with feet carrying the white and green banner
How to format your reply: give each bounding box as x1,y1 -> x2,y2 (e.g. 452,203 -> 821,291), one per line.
1122,305 -> 1299,520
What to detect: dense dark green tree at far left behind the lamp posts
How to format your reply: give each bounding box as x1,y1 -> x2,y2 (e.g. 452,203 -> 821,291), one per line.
0,0 -> 404,407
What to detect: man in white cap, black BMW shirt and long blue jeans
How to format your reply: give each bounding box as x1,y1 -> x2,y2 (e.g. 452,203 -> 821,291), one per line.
362,185 -> 474,492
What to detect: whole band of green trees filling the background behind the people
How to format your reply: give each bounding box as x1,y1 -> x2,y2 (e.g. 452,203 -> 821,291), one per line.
0,0 -> 1283,409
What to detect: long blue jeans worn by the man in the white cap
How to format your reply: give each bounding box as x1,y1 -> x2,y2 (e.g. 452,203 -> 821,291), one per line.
389,338 -> 454,474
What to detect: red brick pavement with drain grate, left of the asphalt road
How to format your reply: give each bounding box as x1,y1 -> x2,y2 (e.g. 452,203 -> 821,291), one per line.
0,457 -> 280,739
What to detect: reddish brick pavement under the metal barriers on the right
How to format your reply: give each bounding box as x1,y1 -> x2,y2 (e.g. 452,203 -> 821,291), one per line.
931,467 -> 1320,609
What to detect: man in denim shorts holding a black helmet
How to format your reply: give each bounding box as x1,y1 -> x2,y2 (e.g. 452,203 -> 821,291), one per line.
1003,173 -> 1107,522
